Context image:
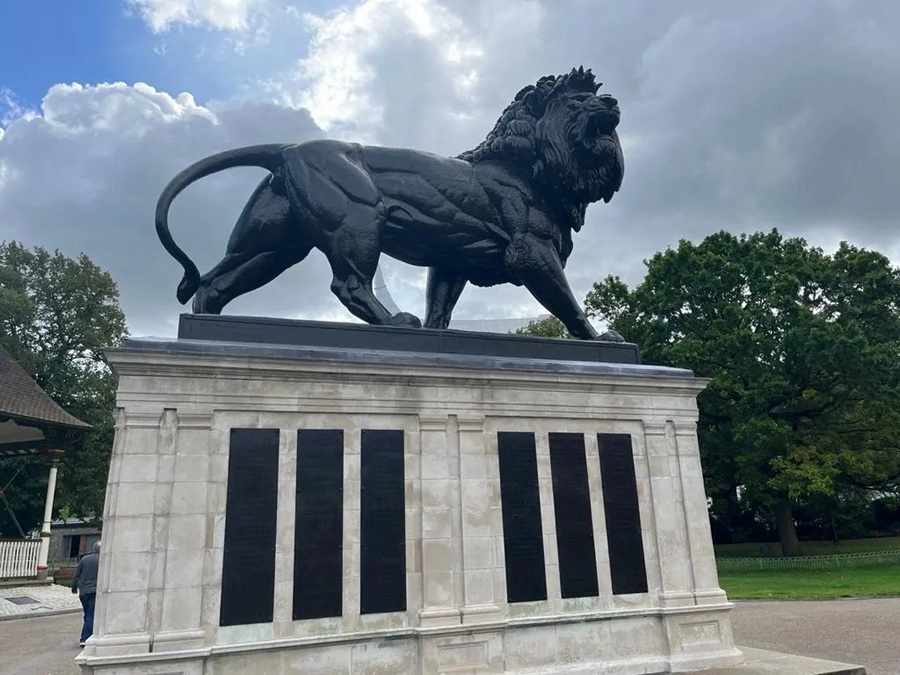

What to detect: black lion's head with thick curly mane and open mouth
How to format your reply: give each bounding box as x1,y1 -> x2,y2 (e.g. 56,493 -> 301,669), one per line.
458,67 -> 625,229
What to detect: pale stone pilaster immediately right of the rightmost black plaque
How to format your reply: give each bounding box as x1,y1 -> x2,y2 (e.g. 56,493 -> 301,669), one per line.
644,420 -> 694,607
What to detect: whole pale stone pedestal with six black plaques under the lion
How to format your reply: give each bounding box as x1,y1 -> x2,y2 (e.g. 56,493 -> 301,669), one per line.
78,320 -> 740,675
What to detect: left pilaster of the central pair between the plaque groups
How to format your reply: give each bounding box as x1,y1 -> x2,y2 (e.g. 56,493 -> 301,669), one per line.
419,415 -> 460,626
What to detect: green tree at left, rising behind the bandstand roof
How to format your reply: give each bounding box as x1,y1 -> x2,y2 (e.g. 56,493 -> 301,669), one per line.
0,242 -> 127,535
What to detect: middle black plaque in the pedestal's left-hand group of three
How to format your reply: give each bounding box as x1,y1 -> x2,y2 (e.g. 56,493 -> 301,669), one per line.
293,429 -> 344,620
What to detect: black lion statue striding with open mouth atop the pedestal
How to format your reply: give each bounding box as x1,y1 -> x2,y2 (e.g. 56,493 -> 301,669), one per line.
156,68 -> 624,341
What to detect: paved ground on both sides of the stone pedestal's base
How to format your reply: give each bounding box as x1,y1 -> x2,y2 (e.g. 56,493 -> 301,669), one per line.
0,598 -> 900,675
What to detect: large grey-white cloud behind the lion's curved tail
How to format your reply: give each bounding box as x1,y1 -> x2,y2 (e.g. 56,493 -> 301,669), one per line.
0,83 -> 326,334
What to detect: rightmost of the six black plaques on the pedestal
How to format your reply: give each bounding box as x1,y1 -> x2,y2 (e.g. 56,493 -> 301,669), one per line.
597,434 -> 647,595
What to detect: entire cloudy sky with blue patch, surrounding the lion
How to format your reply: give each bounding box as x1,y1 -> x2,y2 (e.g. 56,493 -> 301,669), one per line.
0,0 -> 900,335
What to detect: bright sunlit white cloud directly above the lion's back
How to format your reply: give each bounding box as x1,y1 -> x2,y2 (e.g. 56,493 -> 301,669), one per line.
277,0 -> 544,152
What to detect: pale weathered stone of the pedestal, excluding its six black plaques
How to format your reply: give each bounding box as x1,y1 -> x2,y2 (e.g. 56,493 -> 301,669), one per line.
81,340 -> 740,674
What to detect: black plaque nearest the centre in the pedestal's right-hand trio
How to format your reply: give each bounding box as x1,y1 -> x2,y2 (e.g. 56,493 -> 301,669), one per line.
497,431 -> 547,602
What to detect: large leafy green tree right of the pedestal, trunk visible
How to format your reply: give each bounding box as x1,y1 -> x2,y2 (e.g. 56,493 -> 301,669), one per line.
586,230 -> 900,555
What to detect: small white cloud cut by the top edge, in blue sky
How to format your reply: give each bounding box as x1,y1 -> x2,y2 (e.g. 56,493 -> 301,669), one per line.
126,0 -> 266,33
